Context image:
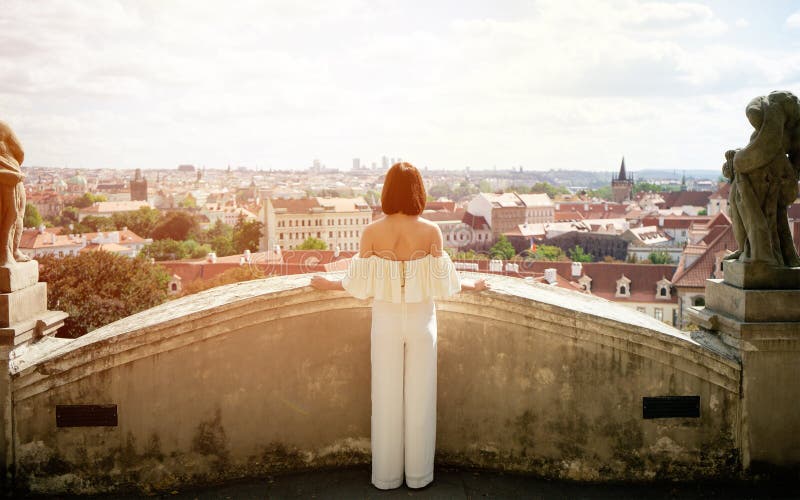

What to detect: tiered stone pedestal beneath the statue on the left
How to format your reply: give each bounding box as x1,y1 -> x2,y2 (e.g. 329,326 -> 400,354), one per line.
0,260 -> 67,485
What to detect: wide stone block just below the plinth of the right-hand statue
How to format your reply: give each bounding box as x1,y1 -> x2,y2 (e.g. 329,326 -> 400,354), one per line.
706,279 -> 800,323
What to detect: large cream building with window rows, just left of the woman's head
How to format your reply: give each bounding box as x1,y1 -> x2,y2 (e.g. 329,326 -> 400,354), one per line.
261,197 -> 372,251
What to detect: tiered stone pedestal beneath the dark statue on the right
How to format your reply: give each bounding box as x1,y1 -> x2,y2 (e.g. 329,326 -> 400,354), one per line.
689,262 -> 800,472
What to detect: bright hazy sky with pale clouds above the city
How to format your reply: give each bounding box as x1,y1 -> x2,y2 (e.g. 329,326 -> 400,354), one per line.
0,0 -> 800,171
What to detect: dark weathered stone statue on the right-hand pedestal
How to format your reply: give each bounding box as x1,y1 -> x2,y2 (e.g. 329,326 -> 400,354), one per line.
722,91 -> 800,267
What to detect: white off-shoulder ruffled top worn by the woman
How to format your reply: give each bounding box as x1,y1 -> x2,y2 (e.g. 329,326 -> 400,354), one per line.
342,253 -> 461,303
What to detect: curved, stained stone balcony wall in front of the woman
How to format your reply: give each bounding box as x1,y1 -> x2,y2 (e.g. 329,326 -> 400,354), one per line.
11,275 -> 740,493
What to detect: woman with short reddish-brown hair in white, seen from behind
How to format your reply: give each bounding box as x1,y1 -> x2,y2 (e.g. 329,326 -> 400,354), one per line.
311,163 -> 488,489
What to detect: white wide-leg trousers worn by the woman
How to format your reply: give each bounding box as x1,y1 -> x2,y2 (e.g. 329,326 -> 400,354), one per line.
371,300 -> 436,489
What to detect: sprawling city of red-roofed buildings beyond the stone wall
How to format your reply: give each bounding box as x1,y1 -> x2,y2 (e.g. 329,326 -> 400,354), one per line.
21,157 -> 800,336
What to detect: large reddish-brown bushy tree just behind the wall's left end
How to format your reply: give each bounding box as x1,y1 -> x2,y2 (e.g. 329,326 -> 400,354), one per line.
37,251 -> 169,338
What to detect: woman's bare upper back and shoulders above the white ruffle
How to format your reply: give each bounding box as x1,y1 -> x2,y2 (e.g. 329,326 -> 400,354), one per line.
359,213 -> 442,260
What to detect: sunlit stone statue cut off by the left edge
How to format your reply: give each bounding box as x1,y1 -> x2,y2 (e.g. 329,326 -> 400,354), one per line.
0,122 -> 30,266
